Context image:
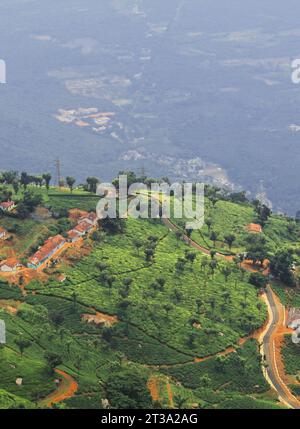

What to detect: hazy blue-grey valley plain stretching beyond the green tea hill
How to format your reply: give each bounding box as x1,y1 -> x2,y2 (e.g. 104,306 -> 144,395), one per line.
0,0 -> 300,213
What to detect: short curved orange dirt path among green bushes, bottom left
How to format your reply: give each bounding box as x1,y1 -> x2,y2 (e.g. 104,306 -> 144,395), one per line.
40,369 -> 78,407
